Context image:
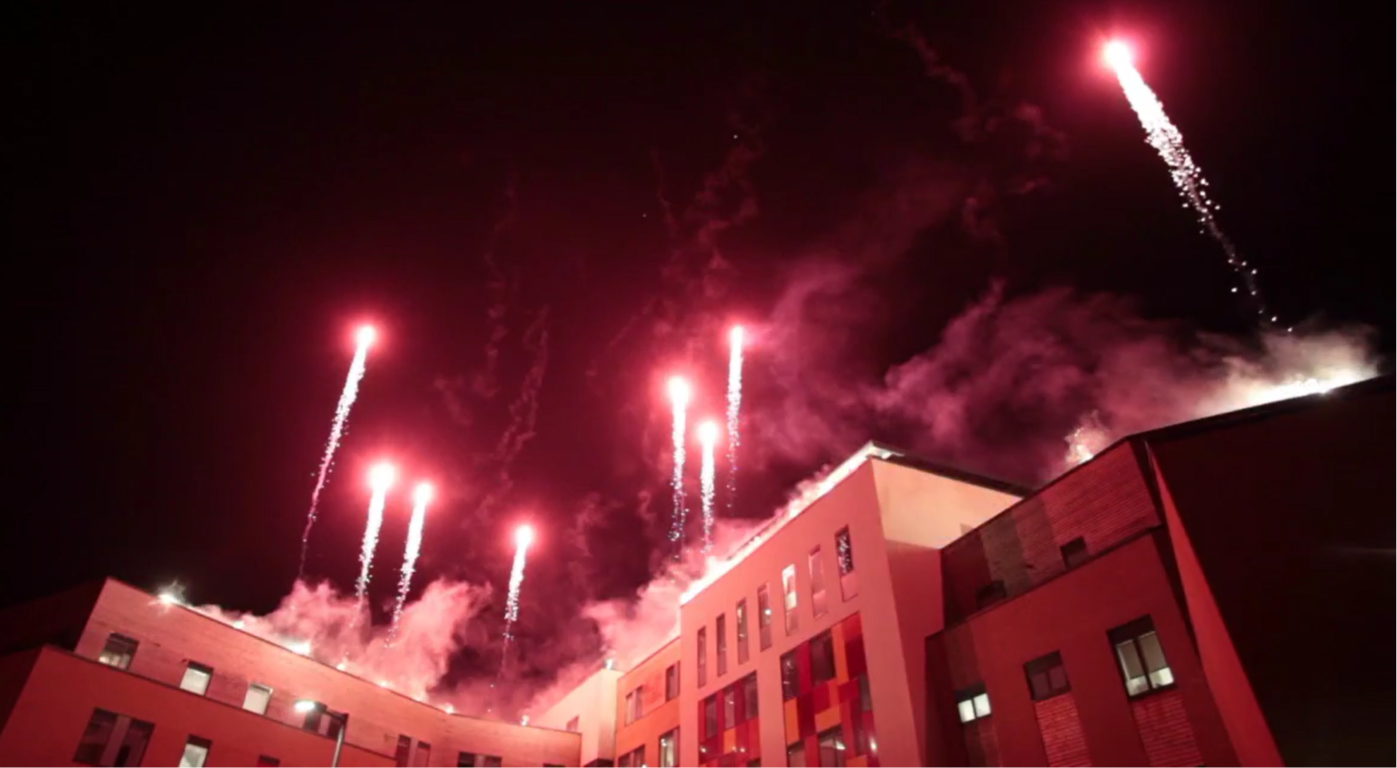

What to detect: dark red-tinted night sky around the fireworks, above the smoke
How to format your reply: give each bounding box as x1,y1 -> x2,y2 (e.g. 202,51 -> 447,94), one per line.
0,0 -> 1397,692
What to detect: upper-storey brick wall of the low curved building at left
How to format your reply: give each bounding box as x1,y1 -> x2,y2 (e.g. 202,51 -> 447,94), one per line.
77,581 -> 581,768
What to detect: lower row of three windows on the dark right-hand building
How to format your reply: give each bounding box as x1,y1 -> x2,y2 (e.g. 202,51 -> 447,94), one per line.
955,616 -> 1173,723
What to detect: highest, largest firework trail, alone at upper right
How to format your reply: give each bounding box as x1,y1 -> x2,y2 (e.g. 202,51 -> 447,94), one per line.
1104,40 -> 1277,324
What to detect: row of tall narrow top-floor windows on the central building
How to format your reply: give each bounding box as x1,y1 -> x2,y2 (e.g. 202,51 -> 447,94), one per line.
697,526 -> 859,687
